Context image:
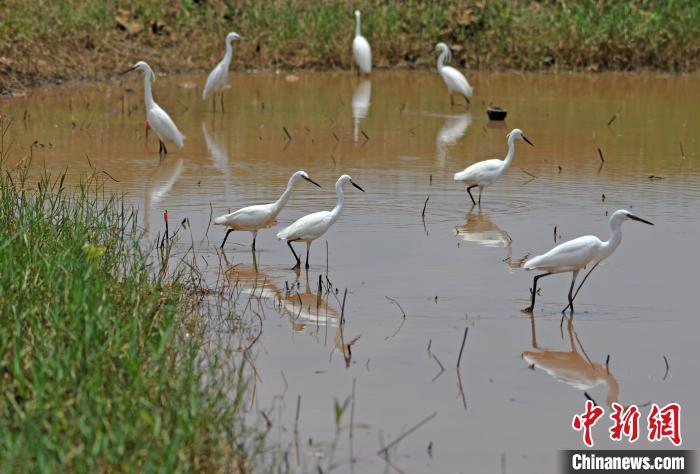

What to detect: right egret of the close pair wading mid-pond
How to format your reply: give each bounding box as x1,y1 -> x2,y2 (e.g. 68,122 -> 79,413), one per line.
277,174 -> 365,268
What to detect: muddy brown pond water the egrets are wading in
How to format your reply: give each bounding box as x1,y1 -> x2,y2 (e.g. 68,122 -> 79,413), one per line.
0,72 -> 700,473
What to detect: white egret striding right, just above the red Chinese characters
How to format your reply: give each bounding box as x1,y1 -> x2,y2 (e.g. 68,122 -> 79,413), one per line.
523,209 -> 654,312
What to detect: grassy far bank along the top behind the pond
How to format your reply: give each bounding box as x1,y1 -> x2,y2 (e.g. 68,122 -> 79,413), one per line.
0,0 -> 700,87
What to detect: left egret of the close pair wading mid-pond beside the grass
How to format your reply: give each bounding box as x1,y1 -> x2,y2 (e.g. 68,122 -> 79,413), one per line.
214,171 -> 321,250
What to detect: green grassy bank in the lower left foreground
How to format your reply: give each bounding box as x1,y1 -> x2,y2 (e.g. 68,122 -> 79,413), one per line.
0,156 -> 264,472
